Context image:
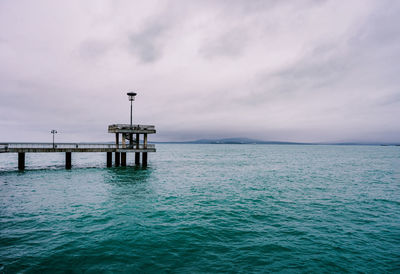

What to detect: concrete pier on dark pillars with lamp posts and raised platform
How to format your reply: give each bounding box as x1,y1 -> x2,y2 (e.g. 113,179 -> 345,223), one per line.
0,93 -> 156,170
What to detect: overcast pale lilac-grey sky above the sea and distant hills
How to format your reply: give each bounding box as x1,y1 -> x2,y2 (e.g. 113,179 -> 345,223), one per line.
0,0 -> 400,142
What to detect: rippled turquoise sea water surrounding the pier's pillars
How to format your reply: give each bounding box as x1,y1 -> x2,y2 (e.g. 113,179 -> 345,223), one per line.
0,144 -> 400,273
